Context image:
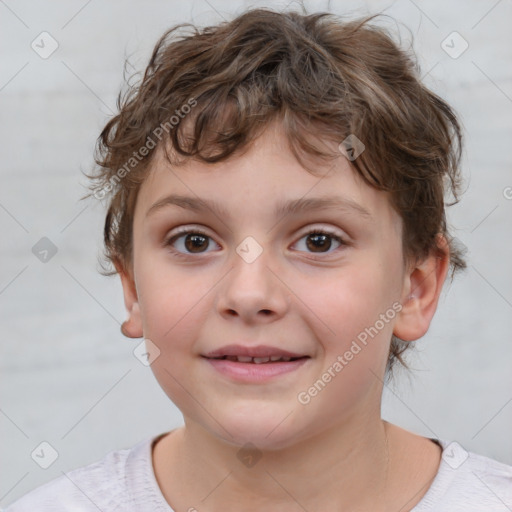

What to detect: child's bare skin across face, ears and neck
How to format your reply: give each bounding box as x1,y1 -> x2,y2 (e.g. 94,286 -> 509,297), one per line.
118,123 -> 449,512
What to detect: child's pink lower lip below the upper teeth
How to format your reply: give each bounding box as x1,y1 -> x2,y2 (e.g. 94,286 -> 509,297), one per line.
205,357 -> 309,382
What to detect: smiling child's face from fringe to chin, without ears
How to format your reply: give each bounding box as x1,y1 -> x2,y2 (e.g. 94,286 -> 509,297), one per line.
123,125 -> 412,449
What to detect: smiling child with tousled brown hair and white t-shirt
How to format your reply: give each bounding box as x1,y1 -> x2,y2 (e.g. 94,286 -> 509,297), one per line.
7,5 -> 512,512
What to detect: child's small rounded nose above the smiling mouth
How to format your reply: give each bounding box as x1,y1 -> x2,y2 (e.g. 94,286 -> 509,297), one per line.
217,243 -> 290,323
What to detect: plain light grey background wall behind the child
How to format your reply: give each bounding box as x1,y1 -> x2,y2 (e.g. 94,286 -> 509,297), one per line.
0,0 -> 512,505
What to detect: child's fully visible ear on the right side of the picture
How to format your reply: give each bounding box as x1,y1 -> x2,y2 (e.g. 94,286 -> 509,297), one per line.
393,235 -> 450,341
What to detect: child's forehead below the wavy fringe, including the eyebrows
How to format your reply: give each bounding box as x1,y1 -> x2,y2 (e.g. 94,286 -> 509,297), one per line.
136,124 -> 397,228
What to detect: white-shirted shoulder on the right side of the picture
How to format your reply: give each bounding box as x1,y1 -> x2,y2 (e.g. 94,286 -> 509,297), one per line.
413,441 -> 512,512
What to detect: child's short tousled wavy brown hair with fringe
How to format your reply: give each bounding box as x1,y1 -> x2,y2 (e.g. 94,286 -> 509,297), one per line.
86,9 -> 465,368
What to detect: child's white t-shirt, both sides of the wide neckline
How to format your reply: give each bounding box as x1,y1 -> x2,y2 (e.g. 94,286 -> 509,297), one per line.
5,434 -> 512,512
